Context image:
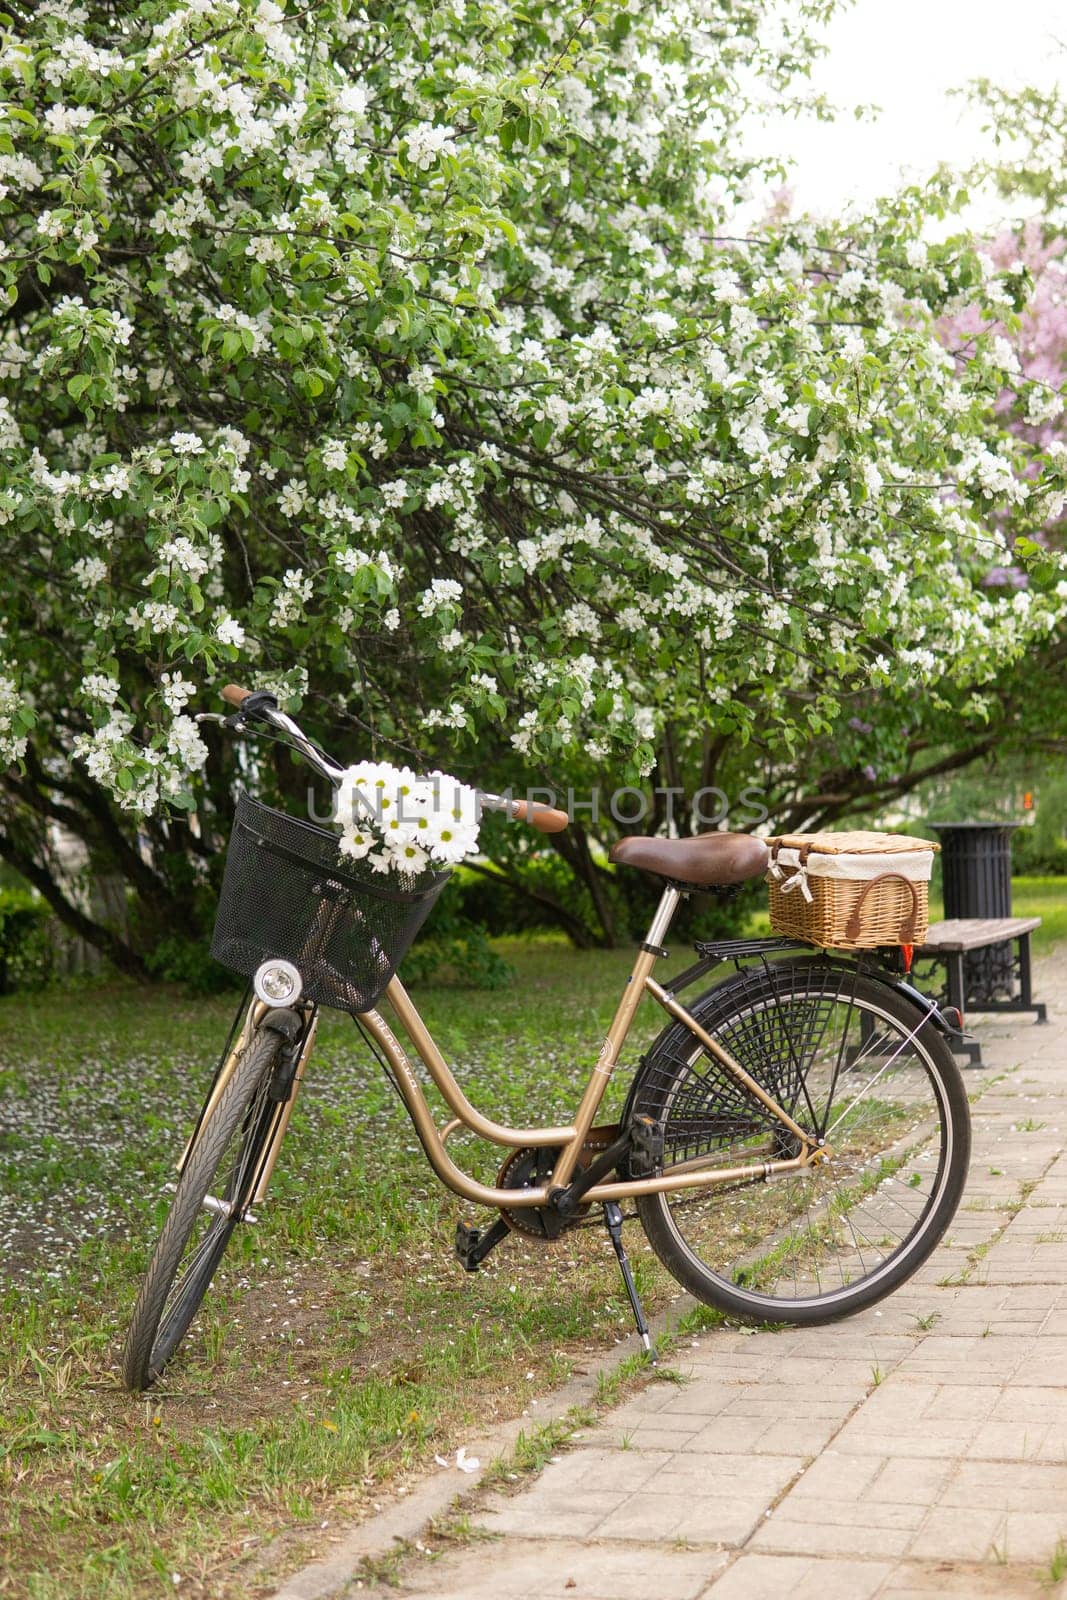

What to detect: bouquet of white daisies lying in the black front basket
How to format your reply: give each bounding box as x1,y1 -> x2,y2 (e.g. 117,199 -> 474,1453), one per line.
334,762 -> 480,875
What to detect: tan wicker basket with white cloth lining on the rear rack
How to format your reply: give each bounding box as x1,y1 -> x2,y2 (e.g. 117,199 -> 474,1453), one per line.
766,832 -> 941,950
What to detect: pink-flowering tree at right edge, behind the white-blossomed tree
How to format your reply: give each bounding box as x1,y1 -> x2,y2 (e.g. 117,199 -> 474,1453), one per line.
748,217 -> 1067,829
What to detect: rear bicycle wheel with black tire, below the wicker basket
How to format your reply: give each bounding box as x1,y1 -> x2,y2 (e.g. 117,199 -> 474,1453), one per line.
629,962 -> 971,1325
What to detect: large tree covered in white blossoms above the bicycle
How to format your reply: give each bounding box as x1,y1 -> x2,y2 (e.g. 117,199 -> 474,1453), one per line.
0,0 -> 1067,953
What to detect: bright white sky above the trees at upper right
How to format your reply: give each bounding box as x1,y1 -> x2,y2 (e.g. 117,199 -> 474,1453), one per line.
752,0 -> 1067,226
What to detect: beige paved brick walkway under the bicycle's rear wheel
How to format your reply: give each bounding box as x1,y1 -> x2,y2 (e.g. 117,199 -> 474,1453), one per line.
289,954 -> 1067,1600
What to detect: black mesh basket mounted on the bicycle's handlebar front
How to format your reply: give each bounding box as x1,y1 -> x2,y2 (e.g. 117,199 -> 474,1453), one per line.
211,794 -> 450,1011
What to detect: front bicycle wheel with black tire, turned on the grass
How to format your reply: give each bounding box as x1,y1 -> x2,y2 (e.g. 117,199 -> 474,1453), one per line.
122,1027 -> 285,1394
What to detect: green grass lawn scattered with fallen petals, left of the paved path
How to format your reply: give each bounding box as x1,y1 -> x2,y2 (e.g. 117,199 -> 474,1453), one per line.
0,880 -> 1067,1600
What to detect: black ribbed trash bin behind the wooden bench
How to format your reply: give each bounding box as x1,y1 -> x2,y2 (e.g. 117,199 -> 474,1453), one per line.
931,822 -> 1022,1005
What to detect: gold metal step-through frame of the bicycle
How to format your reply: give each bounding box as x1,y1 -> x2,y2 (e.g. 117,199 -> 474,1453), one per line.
348,888 -> 829,1210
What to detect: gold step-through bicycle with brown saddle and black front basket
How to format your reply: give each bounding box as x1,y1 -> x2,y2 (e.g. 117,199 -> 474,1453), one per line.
122,685 -> 969,1392
